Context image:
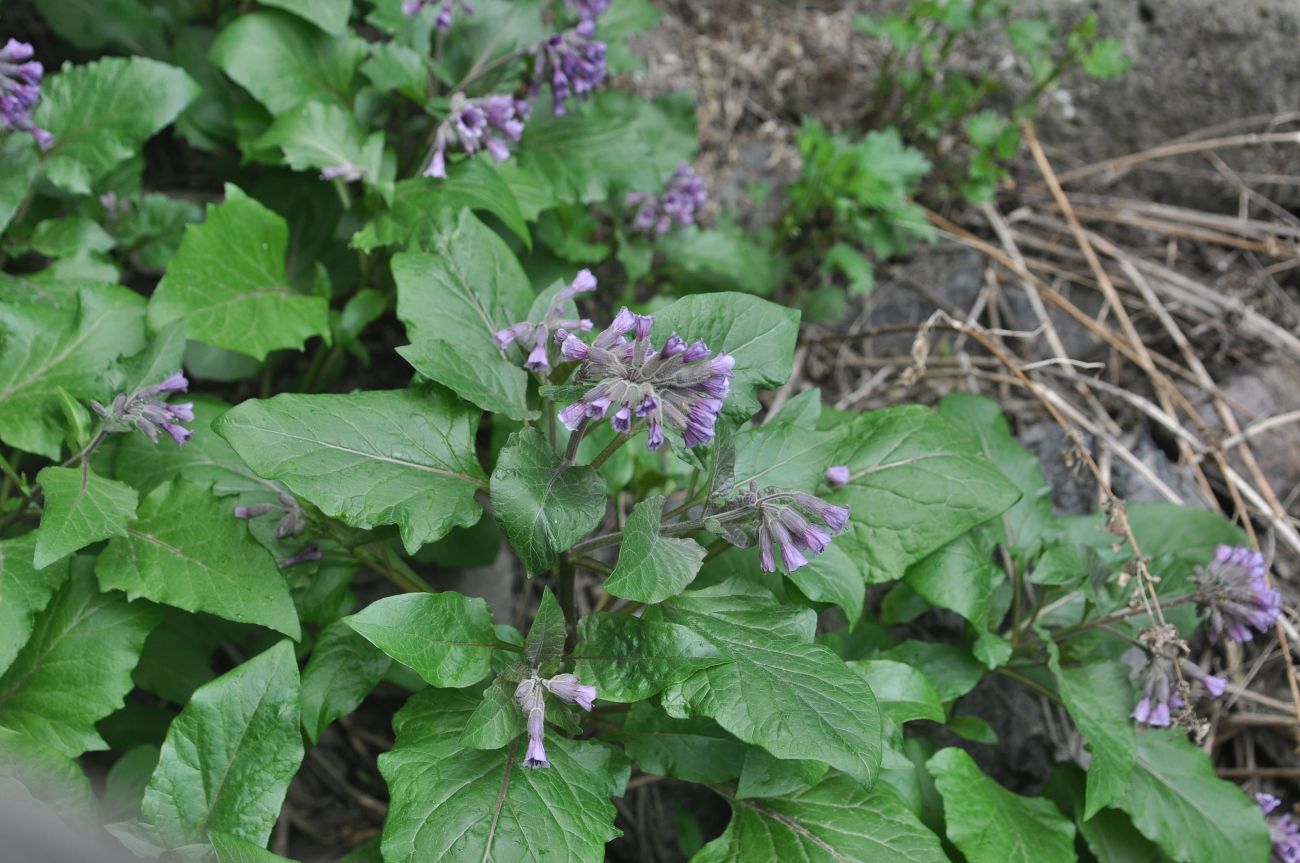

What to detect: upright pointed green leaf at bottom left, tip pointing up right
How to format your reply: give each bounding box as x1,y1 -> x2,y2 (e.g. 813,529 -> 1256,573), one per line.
140,641 -> 303,847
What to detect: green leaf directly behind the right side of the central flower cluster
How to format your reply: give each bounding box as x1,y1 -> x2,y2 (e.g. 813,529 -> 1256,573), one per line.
653,294 -> 800,420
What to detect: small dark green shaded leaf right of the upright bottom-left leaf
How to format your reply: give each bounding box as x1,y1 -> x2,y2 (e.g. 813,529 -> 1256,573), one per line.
302,620 -> 391,743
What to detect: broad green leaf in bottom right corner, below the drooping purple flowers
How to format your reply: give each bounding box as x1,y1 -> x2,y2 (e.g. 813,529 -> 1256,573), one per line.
1115,730 -> 1270,863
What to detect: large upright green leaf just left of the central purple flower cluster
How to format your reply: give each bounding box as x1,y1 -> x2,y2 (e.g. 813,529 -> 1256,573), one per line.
393,209 -> 533,420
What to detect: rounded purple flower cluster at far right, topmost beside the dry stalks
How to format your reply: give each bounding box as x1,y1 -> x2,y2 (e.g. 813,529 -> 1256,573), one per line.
1192,546 -> 1282,642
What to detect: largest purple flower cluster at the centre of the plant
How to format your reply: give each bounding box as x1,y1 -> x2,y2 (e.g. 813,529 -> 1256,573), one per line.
555,308 -> 736,450
